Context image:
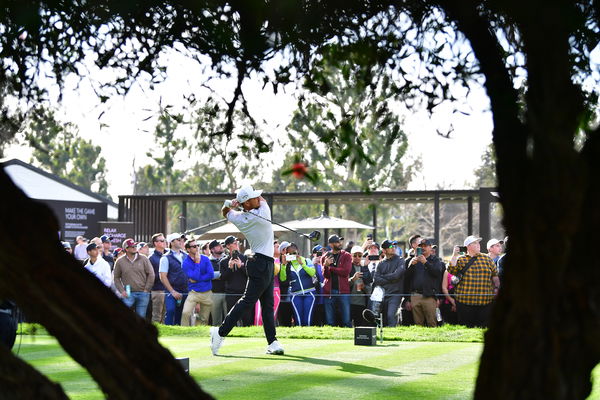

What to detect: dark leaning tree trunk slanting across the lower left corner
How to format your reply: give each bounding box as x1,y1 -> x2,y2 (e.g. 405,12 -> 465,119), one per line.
0,169 -> 211,399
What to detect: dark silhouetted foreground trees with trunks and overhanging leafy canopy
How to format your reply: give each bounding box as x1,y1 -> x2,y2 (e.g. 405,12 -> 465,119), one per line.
0,0 -> 600,400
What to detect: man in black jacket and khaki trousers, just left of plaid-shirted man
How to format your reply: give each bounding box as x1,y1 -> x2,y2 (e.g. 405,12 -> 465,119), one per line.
404,238 -> 446,327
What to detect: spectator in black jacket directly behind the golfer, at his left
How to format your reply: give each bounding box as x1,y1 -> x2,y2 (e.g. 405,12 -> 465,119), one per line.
219,236 -> 254,326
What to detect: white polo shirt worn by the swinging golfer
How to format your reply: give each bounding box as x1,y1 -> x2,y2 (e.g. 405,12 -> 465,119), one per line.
227,201 -> 274,258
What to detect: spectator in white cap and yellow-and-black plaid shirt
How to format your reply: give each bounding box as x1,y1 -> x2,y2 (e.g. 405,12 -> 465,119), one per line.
448,236 -> 500,327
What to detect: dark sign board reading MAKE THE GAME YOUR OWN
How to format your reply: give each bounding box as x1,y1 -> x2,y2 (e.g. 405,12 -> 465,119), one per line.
39,200 -> 108,244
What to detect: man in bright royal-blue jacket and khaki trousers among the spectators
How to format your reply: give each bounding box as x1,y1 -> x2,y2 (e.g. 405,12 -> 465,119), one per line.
181,239 -> 215,326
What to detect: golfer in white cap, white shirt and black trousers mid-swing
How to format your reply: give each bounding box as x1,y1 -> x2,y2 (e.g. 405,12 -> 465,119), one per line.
210,186 -> 283,355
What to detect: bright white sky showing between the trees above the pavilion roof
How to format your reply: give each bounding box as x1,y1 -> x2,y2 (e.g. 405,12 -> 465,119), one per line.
5,52 -> 492,201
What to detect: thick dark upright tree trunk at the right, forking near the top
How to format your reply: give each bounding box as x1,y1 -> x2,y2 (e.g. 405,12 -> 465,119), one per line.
440,0 -> 600,400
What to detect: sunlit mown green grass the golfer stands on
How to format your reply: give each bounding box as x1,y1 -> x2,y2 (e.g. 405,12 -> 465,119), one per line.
15,335 -> 600,400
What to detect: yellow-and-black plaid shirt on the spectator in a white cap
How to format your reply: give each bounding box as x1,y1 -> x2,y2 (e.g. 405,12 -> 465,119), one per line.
448,253 -> 498,306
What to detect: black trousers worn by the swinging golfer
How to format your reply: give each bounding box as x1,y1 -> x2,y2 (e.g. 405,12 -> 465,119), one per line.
219,253 -> 277,344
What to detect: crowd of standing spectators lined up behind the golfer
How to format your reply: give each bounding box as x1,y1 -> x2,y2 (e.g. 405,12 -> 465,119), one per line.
63,233 -> 508,327
